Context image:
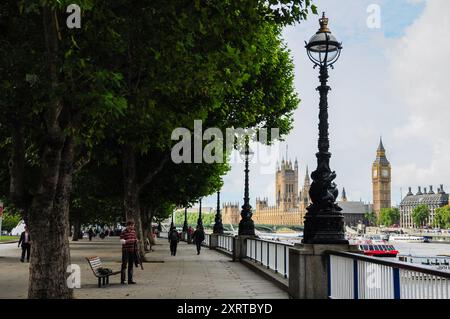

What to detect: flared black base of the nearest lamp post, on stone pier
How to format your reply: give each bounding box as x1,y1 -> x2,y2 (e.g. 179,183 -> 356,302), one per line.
302,211 -> 349,245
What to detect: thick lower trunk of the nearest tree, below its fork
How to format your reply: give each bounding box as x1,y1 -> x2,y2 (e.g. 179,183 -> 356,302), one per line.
28,139 -> 73,299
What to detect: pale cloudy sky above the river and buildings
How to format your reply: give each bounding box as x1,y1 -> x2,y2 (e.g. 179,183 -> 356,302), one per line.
203,0 -> 450,212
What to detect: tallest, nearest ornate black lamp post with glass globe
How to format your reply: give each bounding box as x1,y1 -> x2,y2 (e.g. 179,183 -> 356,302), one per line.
303,13 -> 348,244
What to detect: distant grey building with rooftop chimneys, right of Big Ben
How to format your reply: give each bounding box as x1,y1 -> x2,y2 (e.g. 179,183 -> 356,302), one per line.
400,185 -> 449,228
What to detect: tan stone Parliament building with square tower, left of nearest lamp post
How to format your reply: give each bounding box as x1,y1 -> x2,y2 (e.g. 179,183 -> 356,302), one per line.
222,160 -> 311,226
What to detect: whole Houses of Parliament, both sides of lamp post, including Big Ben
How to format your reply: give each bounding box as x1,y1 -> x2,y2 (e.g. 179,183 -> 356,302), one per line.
222,140 -> 391,226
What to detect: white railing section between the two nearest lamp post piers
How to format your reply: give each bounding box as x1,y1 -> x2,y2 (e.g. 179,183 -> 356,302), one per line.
246,239 -> 294,278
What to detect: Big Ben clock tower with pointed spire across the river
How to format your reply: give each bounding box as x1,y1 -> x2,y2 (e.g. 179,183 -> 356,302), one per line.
372,139 -> 391,216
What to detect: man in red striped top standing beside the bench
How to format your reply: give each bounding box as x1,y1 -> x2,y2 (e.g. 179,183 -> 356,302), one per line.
120,221 -> 138,284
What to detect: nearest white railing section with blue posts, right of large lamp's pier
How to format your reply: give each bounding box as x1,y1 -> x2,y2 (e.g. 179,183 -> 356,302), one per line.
328,252 -> 450,299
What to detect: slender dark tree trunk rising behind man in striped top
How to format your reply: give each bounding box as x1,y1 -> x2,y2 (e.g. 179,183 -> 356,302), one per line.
122,145 -> 145,256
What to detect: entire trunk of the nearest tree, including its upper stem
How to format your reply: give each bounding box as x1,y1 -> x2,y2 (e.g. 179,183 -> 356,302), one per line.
28,6 -> 74,299
